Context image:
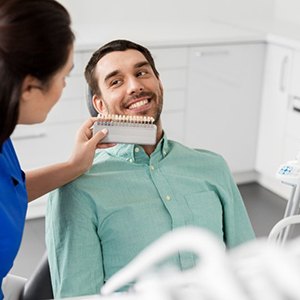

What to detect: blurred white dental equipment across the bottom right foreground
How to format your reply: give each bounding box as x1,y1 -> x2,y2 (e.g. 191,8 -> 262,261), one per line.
99,227 -> 300,300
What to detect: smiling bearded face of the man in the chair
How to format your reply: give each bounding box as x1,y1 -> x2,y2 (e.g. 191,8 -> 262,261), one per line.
93,49 -> 163,123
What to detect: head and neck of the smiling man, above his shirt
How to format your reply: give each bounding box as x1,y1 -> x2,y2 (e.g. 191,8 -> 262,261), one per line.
85,41 -> 163,155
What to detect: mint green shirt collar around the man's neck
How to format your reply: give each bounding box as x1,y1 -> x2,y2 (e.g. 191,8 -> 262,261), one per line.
105,134 -> 169,163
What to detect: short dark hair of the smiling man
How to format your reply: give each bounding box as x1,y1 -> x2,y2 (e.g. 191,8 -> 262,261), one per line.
84,40 -> 159,95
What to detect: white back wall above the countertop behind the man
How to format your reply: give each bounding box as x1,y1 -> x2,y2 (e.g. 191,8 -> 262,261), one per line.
59,0 -> 276,28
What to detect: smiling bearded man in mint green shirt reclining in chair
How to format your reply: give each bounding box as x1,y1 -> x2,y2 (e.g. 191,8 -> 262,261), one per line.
46,40 -> 254,297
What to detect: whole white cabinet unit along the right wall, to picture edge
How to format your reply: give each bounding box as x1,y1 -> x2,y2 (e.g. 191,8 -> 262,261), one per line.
256,44 -> 300,198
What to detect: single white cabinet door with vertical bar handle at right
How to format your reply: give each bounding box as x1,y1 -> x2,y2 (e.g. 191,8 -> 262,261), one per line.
256,44 -> 293,197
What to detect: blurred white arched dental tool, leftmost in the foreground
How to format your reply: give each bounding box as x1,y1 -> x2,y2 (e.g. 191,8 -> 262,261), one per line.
101,227 -> 247,300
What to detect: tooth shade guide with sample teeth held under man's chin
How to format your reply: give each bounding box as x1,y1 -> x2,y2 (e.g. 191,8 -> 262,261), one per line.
93,114 -> 157,145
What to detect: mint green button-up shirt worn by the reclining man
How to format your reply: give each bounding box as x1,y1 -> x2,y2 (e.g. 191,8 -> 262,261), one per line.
46,138 -> 254,297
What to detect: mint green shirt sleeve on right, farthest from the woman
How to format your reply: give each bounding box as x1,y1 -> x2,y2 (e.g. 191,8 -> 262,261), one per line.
219,158 -> 255,248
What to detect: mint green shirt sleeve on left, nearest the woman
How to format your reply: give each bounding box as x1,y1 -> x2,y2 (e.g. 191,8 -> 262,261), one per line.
46,184 -> 104,298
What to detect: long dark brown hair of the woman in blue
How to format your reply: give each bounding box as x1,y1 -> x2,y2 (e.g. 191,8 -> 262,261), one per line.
0,0 -> 74,147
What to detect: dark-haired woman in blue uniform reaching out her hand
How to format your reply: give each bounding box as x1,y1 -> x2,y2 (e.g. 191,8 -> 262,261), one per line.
0,0 -> 109,299
